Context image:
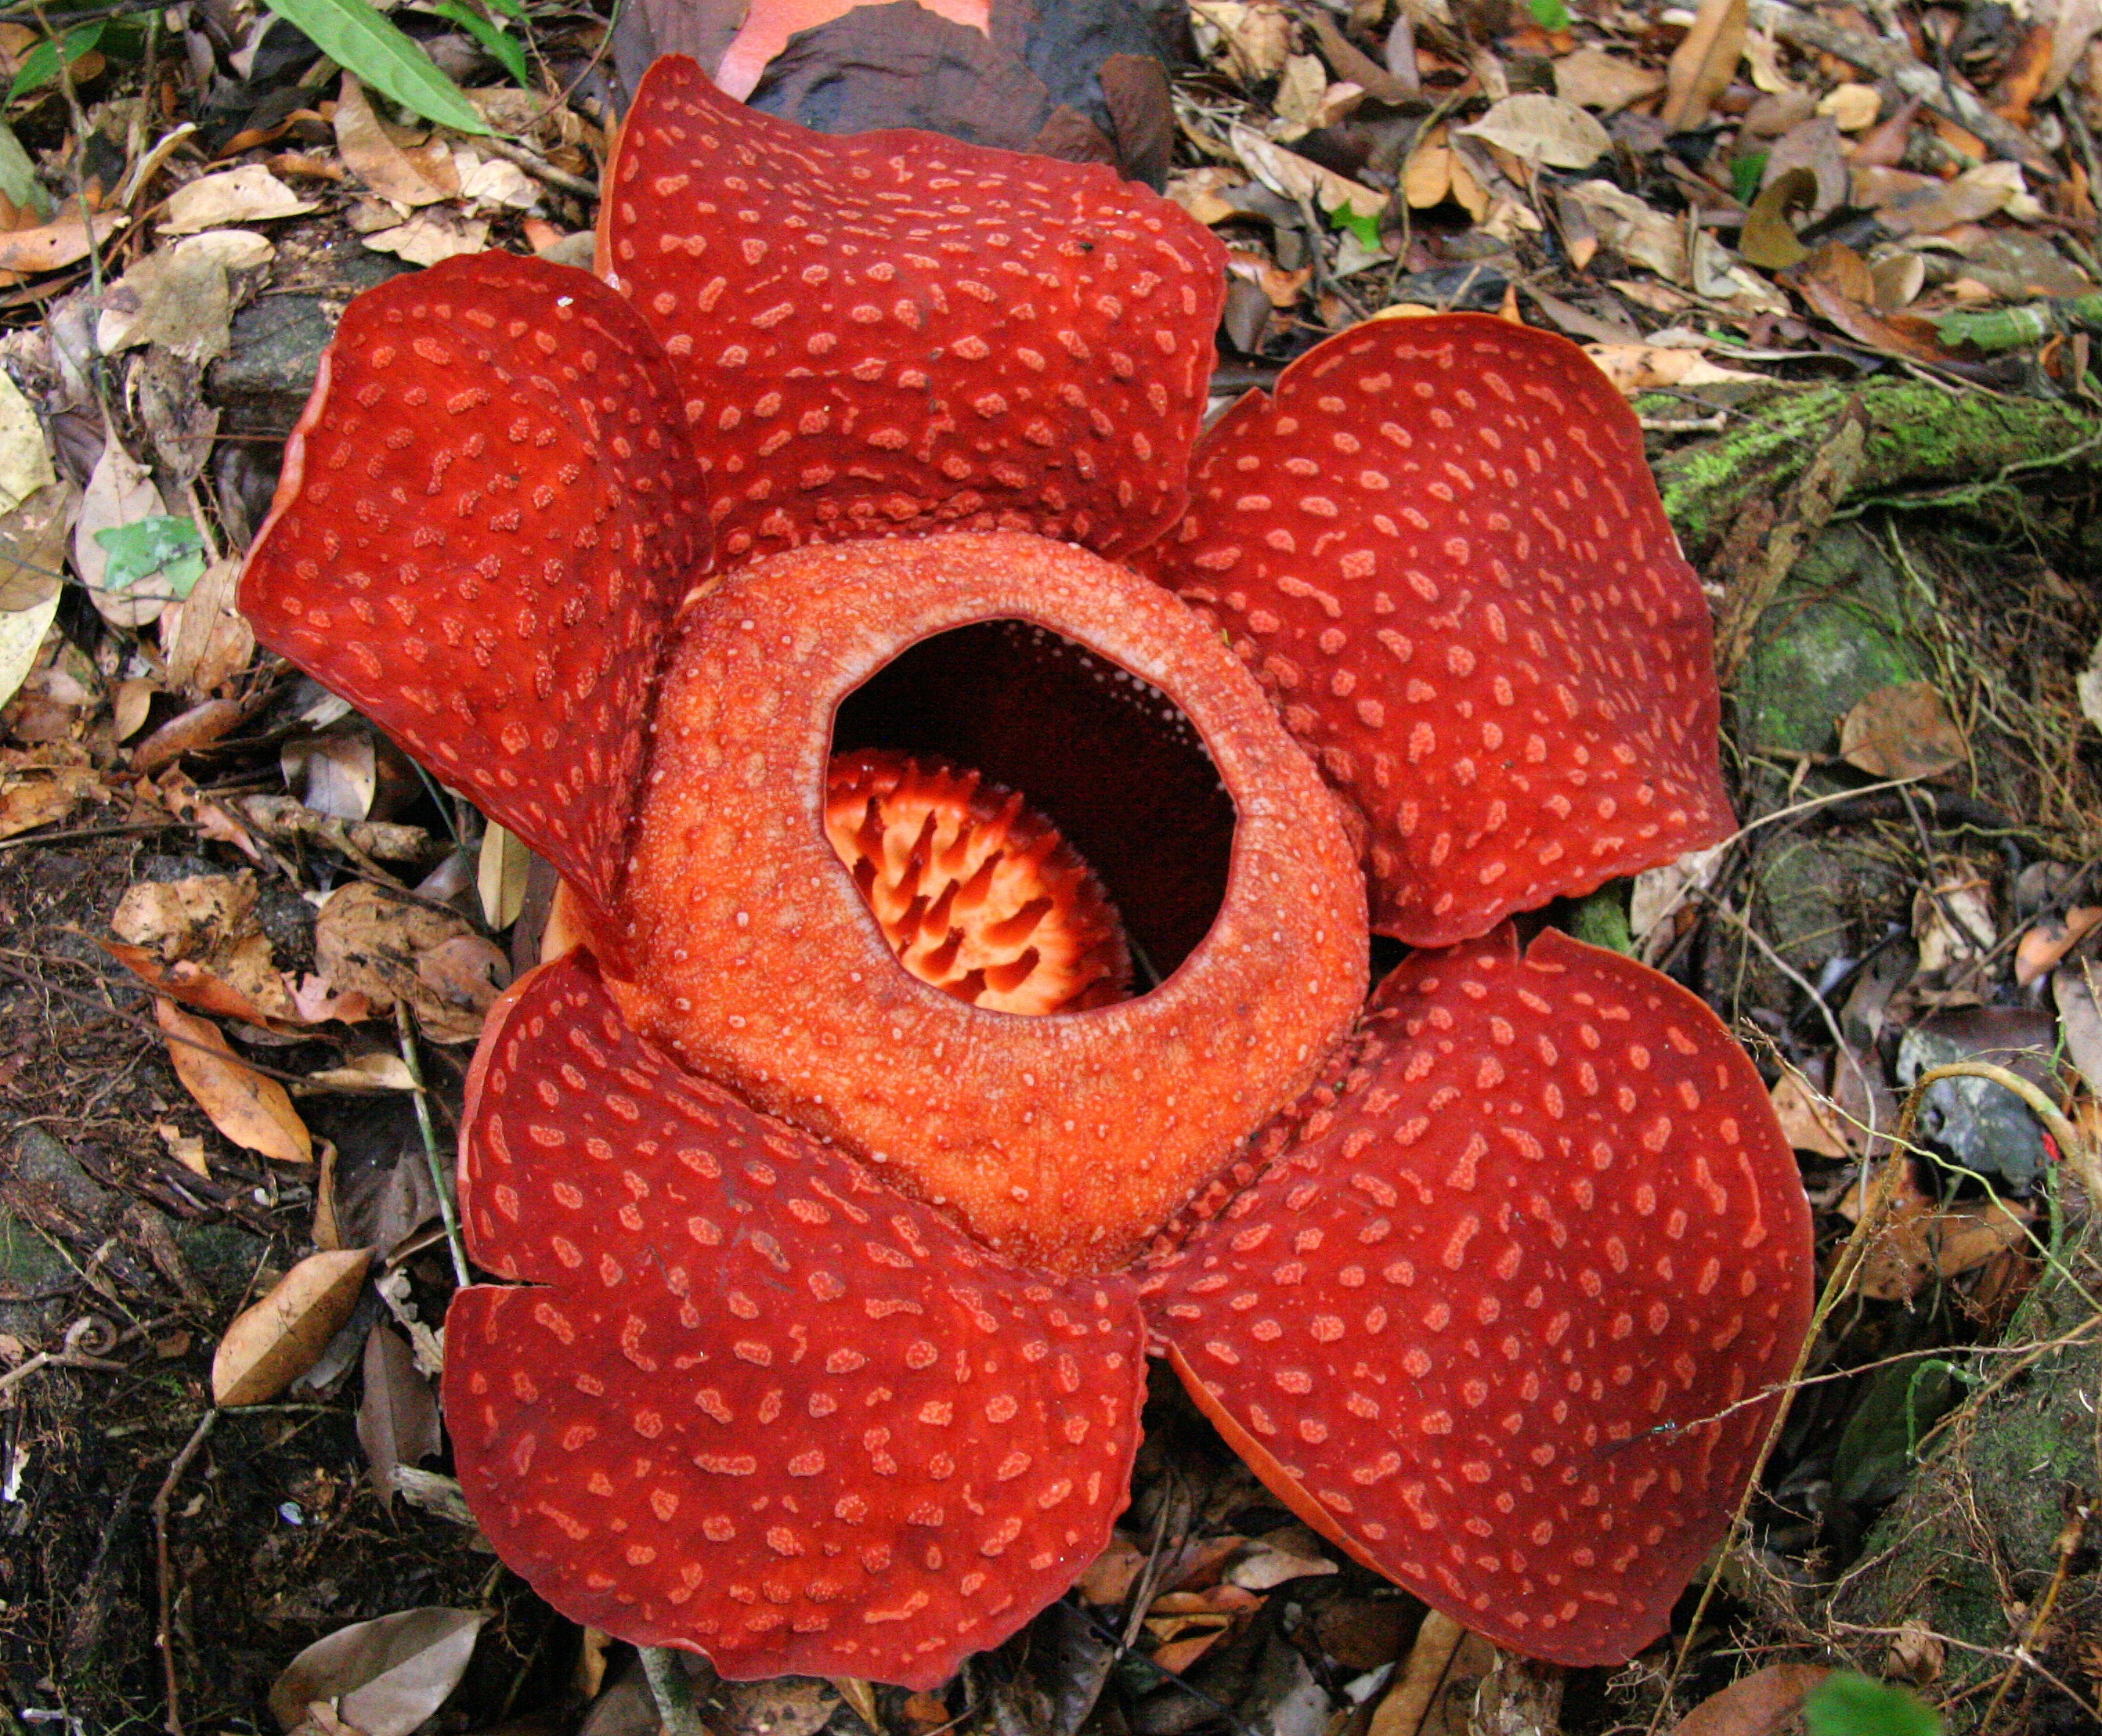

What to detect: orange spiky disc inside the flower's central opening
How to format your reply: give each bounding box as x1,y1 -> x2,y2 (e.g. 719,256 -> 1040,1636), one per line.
824,749 -> 1131,1015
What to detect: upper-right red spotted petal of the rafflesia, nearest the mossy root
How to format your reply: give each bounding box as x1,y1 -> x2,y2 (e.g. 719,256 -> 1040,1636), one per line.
1139,313 -> 1734,946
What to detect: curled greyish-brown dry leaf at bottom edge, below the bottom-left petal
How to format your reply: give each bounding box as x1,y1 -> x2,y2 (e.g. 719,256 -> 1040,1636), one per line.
269,1610 -> 482,1736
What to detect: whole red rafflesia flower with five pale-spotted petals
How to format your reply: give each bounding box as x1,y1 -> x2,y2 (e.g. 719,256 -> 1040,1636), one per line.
242,59 -> 1810,1687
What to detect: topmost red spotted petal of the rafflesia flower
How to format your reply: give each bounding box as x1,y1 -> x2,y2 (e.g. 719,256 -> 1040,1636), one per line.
597,55 -> 1226,561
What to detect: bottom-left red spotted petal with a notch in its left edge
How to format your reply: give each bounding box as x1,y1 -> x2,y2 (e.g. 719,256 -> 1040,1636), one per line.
446,952 -> 1146,1687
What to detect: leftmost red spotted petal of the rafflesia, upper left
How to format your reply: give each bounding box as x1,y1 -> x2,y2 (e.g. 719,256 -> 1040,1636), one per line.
242,252 -> 709,908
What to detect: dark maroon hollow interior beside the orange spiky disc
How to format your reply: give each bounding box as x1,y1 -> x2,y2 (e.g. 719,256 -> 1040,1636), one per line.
832,620 -> 1234,990
